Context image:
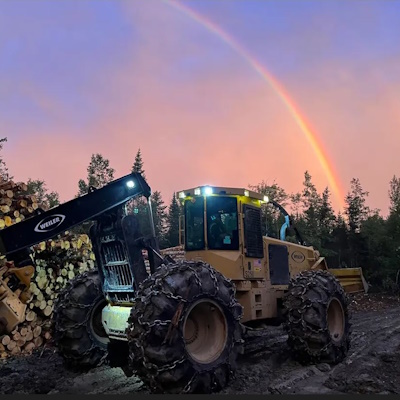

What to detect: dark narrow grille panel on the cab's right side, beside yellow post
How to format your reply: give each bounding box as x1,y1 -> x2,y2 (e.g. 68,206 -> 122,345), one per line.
244,205 -> 264,258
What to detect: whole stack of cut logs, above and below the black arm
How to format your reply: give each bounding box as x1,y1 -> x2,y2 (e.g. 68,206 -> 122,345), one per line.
0,181 -> 95,359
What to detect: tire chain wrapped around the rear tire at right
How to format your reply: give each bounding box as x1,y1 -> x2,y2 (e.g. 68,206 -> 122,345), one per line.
284,270 -> 351,362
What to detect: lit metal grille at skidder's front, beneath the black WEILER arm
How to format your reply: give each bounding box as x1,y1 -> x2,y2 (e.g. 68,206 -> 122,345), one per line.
101,240 -> 133,291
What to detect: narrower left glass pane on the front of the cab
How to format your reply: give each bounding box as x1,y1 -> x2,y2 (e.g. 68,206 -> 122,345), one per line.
185,197 -> 205,250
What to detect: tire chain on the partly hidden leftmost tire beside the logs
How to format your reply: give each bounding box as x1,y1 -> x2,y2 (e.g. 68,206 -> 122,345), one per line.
53,271 -> 107,366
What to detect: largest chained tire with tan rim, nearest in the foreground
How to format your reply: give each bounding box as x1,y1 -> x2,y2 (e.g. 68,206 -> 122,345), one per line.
127,261 -> 243,393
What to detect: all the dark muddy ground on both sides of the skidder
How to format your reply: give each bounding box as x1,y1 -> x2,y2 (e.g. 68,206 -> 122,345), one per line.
0,294 -> 400,394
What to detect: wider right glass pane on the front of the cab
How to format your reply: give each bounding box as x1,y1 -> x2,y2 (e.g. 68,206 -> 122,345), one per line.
207,196 -> 239,250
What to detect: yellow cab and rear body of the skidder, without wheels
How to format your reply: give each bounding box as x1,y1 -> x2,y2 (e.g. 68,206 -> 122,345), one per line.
179,186 -> 368,322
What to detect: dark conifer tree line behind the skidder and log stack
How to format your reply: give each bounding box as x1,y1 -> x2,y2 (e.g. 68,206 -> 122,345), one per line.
0,138 -> 400,290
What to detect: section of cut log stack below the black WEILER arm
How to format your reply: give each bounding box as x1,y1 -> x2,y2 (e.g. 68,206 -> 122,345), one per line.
0,232 -> 95,358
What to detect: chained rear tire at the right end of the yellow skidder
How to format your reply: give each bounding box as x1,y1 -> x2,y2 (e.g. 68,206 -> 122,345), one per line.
284,270 -> 350,364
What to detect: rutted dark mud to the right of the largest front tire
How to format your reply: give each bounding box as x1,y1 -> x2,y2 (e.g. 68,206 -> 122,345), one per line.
223,307 -> 400,394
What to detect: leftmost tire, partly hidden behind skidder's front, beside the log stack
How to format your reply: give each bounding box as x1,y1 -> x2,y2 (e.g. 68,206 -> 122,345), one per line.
53,270 -> 109,369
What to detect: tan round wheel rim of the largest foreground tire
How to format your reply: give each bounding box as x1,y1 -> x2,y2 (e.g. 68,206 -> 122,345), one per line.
183,299 -> 228,364
